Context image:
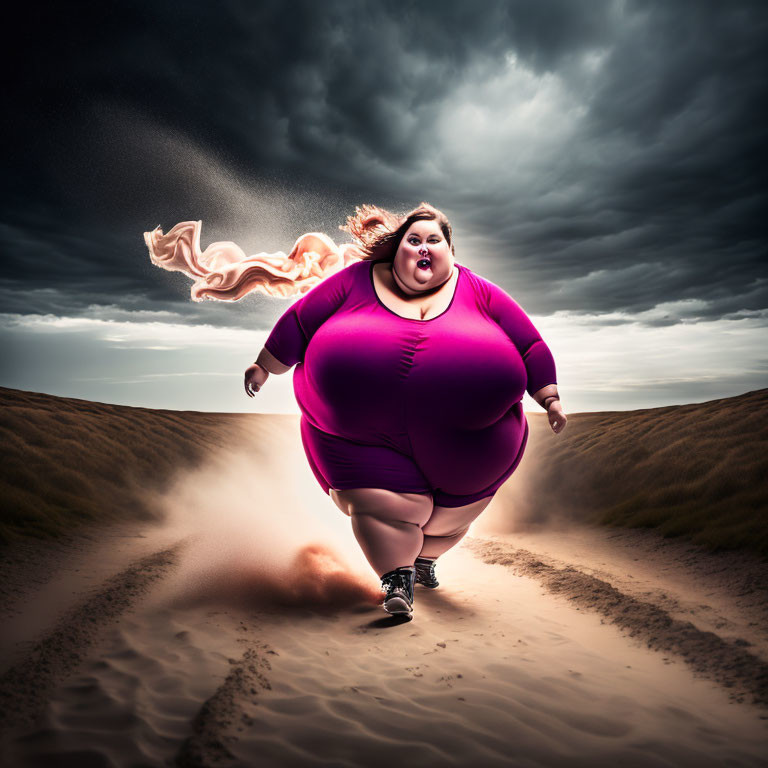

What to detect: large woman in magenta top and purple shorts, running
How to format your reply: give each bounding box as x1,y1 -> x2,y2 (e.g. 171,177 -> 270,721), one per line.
240,203 -> 567,615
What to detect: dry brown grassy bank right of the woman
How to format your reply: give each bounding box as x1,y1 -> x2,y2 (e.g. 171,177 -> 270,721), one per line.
525,389 -> 768,556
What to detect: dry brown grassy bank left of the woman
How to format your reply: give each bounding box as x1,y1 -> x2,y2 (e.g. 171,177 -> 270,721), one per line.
0,388 -> 293,543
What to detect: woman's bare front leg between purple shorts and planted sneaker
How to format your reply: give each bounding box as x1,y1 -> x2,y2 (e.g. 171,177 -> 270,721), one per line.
330,488 -> 433,576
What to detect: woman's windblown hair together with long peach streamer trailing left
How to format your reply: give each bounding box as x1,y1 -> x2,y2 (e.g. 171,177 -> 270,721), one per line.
144,203 -> 453,301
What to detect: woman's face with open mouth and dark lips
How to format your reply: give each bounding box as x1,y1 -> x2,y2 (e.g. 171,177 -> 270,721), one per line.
393,219 -> 453,295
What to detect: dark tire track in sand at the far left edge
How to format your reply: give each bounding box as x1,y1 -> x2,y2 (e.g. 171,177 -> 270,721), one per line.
0,539 -> 187,736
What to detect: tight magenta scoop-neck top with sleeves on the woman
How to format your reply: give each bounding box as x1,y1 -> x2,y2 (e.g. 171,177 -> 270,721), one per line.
265,255 -> 557,495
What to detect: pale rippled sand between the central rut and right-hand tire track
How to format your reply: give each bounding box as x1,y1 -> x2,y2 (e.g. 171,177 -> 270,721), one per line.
214,550 -> 768,766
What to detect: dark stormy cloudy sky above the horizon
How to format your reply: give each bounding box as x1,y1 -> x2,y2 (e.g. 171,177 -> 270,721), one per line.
0,0 -> 768,413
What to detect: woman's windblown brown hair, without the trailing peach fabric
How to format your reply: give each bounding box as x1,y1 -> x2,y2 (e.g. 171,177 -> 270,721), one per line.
339,203 -> 455,261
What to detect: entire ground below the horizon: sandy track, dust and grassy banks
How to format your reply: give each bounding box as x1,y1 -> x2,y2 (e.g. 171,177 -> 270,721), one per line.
0,390 -> 768,768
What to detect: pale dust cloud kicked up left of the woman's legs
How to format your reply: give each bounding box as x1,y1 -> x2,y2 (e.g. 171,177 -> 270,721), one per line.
140,417 -> 381,610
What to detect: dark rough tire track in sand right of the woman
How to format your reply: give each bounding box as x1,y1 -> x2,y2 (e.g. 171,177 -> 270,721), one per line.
463,538 -> 768,708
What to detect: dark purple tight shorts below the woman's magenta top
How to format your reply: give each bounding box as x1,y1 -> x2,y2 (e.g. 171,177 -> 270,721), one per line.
301,416 -> 528,507
